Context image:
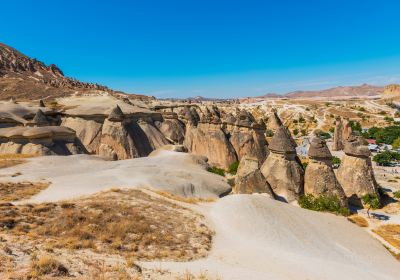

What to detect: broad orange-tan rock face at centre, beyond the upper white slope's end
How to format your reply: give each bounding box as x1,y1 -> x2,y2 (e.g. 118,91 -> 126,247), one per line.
184,123 -> 237,169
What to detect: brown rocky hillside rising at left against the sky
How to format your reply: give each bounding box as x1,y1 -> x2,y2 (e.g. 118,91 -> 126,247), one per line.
0,43 -> 147,100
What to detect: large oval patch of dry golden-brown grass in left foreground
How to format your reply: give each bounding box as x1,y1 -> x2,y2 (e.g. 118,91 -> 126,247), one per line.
0,190 -> 213,260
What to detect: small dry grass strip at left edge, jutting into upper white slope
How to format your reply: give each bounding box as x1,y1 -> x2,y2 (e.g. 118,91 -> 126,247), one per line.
0,182 -> 50,202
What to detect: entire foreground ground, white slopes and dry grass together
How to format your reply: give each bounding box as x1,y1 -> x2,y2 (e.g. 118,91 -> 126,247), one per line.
0,152 -> 400,280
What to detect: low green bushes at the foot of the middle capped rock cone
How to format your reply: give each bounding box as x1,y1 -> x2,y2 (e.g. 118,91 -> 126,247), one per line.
299,194 -> 350,216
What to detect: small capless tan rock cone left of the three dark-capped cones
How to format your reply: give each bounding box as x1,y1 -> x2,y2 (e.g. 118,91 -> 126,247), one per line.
235,156 -> 274,198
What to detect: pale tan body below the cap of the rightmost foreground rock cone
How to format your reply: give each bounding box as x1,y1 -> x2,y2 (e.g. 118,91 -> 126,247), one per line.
337,155 -> 379,206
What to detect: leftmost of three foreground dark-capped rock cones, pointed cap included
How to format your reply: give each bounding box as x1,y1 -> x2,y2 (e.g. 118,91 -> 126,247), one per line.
261,126 -> 304,202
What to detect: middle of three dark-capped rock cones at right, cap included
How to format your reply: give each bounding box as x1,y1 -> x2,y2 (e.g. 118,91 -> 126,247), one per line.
304,136 -> 346,206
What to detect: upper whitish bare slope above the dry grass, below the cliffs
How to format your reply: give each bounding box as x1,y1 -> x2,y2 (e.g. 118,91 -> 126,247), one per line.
0,151 -> 230,202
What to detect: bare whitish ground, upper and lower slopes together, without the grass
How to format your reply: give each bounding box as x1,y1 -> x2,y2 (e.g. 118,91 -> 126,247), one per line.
0,151 -> 400,280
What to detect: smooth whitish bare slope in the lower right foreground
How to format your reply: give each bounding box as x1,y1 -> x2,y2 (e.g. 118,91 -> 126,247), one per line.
145,195 -> 400,280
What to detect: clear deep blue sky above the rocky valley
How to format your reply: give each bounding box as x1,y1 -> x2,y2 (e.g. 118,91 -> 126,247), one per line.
0,0 -> 400,97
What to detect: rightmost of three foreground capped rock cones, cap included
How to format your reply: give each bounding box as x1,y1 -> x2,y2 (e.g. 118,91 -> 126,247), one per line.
337,135 -> 379,206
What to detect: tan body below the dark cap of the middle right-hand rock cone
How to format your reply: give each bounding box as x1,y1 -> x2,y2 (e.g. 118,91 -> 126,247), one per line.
304,159 -> 347,206
